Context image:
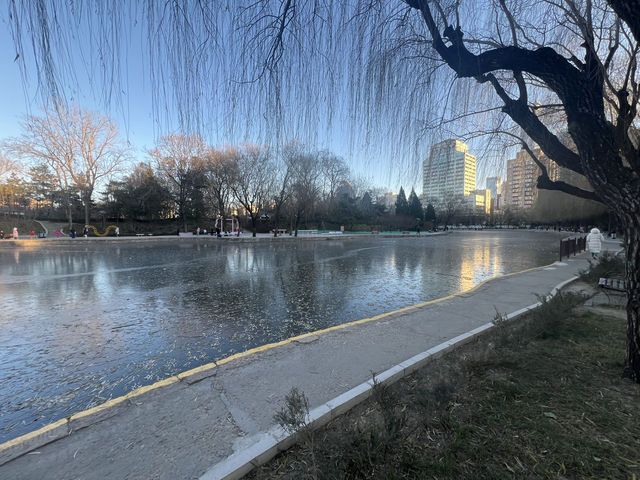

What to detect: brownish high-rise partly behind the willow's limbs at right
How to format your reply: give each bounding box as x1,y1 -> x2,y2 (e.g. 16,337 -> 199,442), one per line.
503,148 -> 558,209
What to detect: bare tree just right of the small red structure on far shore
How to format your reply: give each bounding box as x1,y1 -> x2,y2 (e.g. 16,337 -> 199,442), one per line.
231,145 -> 275,237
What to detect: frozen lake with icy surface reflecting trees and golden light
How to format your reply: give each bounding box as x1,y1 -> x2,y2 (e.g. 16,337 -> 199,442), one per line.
0,231 -> 560,442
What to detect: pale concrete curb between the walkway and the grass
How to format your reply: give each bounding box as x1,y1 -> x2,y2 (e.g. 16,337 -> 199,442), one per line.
200,276 -> 579,480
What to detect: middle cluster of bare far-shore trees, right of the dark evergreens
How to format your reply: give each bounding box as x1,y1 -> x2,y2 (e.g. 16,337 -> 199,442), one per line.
145,134 -> 349,235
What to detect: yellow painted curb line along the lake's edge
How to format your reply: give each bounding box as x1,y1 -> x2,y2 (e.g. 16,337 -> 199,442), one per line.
0,261 -> 559,465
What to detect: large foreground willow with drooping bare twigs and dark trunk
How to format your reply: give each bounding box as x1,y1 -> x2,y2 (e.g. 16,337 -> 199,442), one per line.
9,0 -> 640,382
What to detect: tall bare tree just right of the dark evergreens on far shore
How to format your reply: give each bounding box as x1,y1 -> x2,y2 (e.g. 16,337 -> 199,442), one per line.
148,133 -> 207,231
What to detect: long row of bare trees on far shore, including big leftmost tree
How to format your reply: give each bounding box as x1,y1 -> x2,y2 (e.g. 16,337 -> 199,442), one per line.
0,108 -> 370,235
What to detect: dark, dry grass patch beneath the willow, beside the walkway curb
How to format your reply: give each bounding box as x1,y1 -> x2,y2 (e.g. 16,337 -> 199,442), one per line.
249,295 -> 640,479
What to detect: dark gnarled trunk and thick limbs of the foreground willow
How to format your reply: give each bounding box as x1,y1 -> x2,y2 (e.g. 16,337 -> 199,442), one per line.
407,0 -> 640,382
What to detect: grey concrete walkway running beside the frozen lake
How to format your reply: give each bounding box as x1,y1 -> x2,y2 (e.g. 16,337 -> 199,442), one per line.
0,243 -> 617,480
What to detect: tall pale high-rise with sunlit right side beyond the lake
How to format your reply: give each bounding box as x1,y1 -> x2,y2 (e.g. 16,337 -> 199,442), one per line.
422,140 -> 476,201
